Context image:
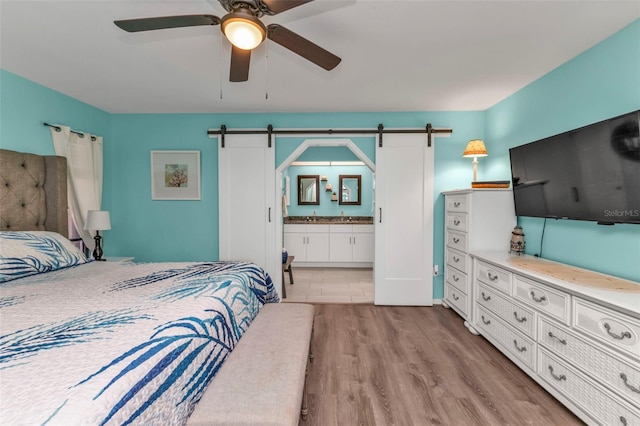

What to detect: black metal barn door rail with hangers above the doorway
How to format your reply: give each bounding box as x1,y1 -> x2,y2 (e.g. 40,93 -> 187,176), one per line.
207,123 -> 453,148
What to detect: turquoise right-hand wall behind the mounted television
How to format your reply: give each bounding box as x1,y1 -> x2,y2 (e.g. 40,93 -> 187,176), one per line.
488,20 -> 640,281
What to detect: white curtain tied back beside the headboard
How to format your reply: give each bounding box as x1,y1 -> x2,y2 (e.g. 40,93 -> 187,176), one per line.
51,125 -> 102,250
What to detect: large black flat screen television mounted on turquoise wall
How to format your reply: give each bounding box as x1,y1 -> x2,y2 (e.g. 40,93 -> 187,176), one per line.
509,110 -> 640,224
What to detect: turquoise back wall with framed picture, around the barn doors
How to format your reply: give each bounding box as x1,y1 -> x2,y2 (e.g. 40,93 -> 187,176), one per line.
110,112 -> 484,299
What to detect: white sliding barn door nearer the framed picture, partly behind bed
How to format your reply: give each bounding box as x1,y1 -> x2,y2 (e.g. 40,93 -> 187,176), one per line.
218,134 -> 282,288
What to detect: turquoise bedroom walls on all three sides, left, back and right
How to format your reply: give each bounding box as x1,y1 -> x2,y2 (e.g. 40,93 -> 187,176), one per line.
0,21 -> 640,299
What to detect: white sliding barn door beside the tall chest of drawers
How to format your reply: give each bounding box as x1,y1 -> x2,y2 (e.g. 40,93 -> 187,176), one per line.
374,133 -> 434,306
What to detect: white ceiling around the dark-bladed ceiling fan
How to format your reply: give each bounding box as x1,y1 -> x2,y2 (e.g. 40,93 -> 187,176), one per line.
0,0 -> 640,113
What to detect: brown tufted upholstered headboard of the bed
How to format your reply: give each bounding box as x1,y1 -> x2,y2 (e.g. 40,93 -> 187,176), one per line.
0,149 -> 69,237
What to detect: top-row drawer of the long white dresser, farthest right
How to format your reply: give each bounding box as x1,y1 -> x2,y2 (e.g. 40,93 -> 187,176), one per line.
573,297 -> 640,359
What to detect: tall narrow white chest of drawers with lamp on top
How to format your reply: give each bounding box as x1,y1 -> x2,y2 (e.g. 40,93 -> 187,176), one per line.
442,189 -> 516,334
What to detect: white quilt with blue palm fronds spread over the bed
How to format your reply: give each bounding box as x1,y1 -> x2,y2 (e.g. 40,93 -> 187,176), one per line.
0,262 -> 279,425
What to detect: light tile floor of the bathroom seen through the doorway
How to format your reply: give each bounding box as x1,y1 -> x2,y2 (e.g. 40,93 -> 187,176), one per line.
282,262 -> 373,303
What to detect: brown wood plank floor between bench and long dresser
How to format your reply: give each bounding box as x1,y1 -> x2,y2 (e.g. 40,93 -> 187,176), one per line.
300,304 -> 582,426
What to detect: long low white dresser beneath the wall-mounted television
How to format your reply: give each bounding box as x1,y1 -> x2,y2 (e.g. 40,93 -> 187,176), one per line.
470,251 -> 640,426
